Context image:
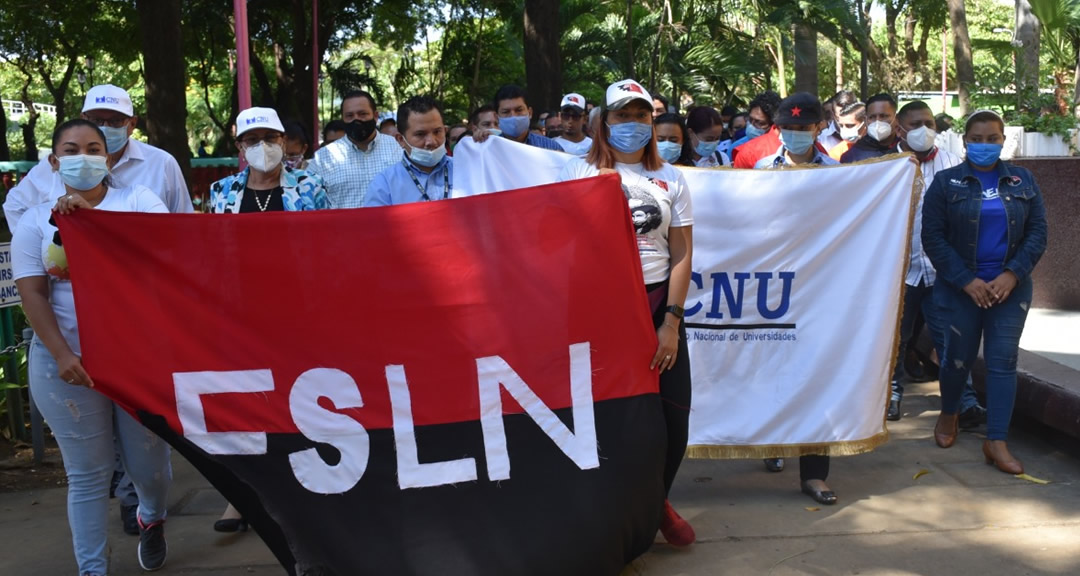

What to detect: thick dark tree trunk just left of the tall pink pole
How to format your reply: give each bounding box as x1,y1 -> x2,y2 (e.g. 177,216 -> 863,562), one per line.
135,0 -> 191,183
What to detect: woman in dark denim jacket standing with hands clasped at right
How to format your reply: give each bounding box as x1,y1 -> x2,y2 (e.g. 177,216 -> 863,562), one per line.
922,110 -> 1047,474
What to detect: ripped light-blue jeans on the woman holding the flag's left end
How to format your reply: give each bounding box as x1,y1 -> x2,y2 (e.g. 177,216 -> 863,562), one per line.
30,338 -> 173,575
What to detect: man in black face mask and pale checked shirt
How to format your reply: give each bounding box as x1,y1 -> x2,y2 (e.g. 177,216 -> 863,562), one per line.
308,90 -> 402,209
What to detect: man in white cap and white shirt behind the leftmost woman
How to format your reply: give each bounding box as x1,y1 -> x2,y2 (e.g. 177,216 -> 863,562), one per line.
3,84 -> 194,229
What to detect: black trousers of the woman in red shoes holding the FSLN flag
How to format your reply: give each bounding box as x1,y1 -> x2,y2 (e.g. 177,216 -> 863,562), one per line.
649,283 -> 690,494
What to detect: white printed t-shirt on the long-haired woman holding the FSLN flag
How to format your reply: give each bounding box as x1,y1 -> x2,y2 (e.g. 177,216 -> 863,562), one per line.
558,158 -> 693,284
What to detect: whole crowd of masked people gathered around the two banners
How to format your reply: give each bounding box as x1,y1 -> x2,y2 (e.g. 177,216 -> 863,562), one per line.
3,79 -> 1047,576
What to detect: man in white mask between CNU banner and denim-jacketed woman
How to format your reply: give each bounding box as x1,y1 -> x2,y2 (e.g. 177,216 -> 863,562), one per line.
887,101 -> 986,421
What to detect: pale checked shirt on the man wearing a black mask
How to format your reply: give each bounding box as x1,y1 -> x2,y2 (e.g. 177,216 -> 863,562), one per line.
308,133 -> 402,209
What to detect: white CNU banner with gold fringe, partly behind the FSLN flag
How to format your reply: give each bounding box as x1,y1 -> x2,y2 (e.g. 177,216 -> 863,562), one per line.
454,138 -> 921,458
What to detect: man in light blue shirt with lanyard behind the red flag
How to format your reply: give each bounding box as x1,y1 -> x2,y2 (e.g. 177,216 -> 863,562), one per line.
364,96 -> 454,207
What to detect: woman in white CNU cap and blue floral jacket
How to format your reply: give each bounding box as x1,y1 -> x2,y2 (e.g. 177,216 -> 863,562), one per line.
210,108 -> 329,214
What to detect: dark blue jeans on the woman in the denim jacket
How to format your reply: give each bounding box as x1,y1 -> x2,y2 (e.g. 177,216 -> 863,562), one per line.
933,278 -> 1031,440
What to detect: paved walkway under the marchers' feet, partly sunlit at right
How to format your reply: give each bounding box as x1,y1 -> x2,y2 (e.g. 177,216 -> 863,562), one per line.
0,384 -> 1080,576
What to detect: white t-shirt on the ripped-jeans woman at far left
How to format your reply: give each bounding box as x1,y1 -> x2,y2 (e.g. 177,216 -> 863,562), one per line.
11,186 -> 168,354
